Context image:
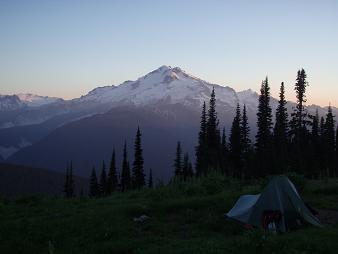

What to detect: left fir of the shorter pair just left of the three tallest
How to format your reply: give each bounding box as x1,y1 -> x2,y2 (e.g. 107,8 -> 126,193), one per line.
229,104 -> 243,178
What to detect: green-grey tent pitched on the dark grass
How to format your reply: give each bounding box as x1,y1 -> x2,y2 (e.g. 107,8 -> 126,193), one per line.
226,176 -> 321,232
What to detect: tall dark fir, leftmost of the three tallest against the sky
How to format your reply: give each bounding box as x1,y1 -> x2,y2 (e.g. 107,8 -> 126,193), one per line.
255,77 -> 272,176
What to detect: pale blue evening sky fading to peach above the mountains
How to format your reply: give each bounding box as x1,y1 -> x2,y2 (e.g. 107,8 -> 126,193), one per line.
0,0 -> 338,106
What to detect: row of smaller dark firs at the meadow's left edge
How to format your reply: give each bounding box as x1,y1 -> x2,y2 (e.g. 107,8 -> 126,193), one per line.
64,127 -> 153,198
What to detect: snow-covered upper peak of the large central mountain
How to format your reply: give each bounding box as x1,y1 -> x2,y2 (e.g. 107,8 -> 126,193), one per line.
79,65 -> 238,106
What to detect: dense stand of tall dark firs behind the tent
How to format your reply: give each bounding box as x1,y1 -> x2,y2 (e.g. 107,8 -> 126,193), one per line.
191,69 -> 338,179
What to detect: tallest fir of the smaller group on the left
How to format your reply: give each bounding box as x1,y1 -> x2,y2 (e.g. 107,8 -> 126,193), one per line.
133,127 -> 145,189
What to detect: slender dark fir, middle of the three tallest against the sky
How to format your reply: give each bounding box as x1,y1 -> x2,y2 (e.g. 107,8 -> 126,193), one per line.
273,82 -> 289,174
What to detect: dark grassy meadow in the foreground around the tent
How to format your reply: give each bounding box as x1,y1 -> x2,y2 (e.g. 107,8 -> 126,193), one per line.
0,176 -> 338,254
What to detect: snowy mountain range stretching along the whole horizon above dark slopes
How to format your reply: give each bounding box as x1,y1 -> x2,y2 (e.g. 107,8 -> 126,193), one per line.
0,65 -> 332,129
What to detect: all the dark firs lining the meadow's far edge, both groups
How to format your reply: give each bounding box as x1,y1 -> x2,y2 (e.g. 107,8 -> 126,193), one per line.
64,69 -> 338,197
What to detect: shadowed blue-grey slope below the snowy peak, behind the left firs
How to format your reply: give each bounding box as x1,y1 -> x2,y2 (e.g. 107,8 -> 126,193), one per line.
8,104 -> 203,181
